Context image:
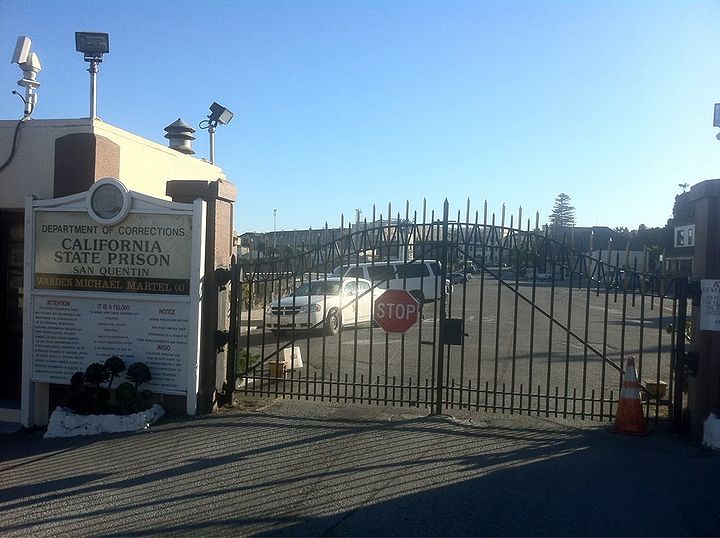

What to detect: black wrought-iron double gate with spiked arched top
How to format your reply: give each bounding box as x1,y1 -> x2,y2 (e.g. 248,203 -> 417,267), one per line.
229,202 -> 688,425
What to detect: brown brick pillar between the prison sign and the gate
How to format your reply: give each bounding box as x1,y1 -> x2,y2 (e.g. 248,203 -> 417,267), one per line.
165,179 -> 237,414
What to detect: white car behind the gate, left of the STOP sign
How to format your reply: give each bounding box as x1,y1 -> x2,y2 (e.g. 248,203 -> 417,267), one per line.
265,277 -> 373,335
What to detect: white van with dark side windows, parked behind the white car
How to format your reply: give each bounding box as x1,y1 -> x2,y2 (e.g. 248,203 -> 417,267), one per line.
343,260 -> 450,305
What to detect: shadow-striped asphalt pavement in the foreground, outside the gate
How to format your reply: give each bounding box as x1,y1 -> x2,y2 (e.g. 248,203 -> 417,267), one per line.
0,400 -> 720,536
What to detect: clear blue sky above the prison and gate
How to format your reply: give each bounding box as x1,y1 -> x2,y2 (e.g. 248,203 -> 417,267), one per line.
0,0 -> 720,232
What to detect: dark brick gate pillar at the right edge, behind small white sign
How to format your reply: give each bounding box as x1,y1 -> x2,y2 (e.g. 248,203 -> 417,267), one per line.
688,179 -> 720,441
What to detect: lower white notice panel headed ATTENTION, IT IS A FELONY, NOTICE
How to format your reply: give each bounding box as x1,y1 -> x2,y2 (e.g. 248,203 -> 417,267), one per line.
32,295 -> 190,394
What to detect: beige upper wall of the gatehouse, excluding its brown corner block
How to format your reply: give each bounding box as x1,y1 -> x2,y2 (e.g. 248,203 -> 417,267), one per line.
0,118 -> 226,205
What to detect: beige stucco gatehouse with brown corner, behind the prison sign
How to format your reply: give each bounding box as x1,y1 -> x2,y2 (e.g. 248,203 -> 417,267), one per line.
0,118 -> 226,421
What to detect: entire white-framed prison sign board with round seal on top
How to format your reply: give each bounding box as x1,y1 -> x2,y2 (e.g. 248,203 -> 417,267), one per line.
21,178 -> 206,426
